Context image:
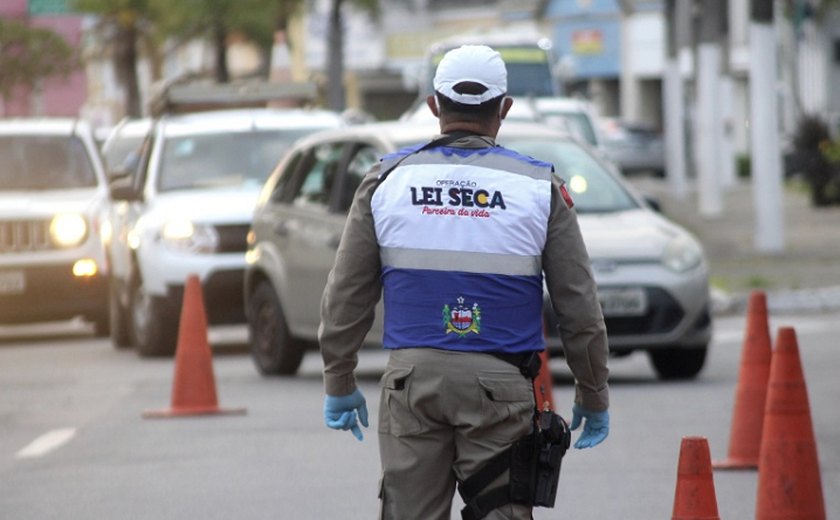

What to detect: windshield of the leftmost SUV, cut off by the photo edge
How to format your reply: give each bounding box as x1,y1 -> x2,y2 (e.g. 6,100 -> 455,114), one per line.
0,135 -> 97,190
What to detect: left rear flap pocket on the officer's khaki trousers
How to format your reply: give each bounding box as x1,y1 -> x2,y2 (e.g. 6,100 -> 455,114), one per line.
379,367 -> 422,437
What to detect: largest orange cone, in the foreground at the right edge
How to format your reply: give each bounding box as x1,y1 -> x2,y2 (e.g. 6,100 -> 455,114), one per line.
755,327 -> 825,520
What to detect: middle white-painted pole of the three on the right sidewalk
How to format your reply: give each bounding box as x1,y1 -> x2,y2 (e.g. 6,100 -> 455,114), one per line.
696,0 -> 724,217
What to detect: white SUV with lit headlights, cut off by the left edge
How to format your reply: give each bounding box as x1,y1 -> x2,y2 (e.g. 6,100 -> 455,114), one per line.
0,118 -> 108,335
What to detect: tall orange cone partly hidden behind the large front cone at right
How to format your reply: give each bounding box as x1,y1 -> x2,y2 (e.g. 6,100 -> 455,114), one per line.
712,291 -> 772,469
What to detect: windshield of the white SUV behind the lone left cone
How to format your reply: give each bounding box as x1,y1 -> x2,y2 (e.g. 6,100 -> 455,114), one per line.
158,129 -> 312,191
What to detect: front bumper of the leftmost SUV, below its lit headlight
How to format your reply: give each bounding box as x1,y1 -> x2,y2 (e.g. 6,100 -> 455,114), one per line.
0,263 -> 108,324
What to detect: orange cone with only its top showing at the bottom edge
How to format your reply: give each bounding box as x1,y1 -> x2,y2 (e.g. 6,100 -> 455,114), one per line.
671,437 -> 720,520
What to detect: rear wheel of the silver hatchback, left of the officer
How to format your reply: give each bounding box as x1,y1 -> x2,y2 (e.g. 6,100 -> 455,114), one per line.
248,282 -> 305,375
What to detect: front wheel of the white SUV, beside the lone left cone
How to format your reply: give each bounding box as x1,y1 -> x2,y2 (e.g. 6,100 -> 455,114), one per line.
130,279 -> 178,357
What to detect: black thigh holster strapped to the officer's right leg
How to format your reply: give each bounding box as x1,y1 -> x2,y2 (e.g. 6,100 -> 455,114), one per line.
458,411 -> 571,520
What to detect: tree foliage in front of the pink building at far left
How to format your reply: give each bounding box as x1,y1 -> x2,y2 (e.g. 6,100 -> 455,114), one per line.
0,18 -> 79,100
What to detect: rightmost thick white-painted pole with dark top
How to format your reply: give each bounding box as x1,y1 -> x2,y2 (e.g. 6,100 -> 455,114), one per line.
750,0 -> 785,253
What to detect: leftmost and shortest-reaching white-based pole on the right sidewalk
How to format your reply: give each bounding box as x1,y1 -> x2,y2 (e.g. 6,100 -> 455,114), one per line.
664,0 -> 690,200
